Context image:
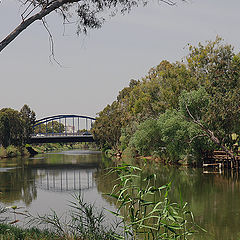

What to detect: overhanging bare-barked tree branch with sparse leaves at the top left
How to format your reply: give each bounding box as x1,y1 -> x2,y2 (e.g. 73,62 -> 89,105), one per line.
0,0 -> 183,53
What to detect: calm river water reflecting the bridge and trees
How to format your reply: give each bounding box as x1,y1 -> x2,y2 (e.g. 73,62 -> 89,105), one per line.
0,150 -> 240,240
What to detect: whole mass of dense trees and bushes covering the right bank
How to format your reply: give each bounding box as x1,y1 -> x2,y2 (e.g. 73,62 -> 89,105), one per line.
93,37 -> 240,165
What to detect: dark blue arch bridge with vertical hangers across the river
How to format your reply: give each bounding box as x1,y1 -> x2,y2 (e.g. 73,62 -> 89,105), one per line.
30,114 -> 96,143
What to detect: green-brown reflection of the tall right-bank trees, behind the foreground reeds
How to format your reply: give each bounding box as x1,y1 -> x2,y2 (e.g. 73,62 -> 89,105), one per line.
96,161 -> 240,240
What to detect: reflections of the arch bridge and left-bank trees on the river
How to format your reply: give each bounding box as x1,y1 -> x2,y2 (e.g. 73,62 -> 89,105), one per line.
0,150 -> 101,207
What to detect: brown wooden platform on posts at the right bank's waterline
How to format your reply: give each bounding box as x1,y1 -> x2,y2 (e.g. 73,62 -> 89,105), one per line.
203,151 -> 240,172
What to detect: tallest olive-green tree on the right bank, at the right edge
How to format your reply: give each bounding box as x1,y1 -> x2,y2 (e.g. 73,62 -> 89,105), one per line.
187,37 -> 240,147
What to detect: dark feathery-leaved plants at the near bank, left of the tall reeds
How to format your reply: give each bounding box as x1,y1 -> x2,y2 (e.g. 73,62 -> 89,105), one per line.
29,195 -> 116,240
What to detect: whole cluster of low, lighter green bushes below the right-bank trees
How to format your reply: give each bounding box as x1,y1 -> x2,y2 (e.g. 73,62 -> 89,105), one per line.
130,100 -> 213,163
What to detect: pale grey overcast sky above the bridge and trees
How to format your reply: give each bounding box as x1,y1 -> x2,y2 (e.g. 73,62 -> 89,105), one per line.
0,0 -> 240,119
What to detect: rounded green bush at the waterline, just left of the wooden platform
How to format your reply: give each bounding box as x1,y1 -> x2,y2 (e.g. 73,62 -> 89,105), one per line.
158,110 -> 212,162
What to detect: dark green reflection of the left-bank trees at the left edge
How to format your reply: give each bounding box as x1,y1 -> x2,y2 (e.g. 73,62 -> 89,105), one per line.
0,166 -> 37,205
